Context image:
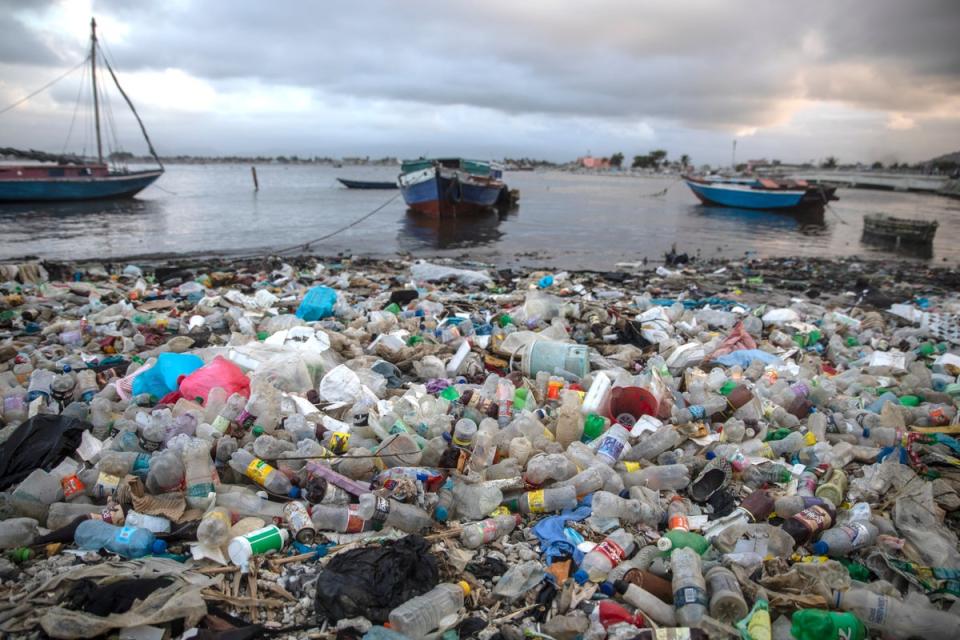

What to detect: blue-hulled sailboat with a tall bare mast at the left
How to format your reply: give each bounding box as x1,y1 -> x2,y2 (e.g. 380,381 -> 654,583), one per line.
0,19 -> 163,202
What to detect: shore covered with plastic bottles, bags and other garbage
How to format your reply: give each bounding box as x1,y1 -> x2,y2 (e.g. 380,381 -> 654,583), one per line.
0,254 -> 960,640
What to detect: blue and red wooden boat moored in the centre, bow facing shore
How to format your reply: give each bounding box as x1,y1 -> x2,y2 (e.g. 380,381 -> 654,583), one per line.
397,158 -> 510,218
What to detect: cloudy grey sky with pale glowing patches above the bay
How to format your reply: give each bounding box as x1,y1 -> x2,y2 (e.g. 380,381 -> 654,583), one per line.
0,0 -> 960,164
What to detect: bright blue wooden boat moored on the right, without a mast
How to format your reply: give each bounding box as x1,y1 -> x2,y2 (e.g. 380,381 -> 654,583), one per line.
684,176 -> 837,211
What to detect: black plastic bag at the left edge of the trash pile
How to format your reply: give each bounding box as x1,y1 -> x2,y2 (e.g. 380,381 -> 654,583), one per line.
0,415 -> 90,491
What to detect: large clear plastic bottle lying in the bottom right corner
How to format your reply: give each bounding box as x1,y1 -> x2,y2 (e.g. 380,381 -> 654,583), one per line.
833,588 -> 960,640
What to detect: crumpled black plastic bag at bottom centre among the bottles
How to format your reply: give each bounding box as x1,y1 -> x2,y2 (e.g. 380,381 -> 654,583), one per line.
316,535 -> 439,624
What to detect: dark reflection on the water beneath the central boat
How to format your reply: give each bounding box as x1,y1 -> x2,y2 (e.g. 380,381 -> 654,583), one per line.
397,207 -> 518,251
